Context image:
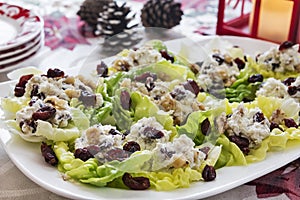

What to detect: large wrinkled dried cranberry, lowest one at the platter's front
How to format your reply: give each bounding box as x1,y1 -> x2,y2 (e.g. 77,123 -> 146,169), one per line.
122,173 -> 150,190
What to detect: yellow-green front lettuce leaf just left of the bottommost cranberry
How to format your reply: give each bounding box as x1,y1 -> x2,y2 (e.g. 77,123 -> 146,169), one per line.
53,142 -> 152,187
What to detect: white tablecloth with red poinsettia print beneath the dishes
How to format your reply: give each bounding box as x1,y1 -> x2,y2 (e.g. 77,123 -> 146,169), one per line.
0,0 -> 300,200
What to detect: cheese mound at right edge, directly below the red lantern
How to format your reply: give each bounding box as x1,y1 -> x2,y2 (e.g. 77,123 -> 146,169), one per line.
256,44 -> 300,73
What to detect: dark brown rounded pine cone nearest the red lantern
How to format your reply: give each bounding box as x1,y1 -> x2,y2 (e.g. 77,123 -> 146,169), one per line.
141,0 -> 183,29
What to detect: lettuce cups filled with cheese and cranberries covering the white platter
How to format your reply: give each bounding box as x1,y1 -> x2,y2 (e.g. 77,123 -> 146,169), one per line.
1,40 -> 300,191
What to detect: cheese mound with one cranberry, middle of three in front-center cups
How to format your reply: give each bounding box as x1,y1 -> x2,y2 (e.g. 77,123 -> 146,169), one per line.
126,117 -> 171,150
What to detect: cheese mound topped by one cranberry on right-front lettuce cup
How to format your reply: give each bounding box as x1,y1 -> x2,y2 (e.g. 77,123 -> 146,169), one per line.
226,103 -> 270,148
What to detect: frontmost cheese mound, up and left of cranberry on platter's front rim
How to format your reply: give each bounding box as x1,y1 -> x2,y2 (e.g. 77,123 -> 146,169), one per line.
152,134 -> 206,171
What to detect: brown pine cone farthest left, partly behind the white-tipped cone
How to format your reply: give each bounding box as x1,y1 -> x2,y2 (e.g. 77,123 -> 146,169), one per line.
77,0 -> 112,31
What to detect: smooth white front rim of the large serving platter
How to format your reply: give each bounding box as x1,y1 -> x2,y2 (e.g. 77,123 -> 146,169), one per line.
0,37 -> 300,199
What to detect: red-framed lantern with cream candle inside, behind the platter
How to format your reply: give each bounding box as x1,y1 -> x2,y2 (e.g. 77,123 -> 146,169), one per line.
216,0 -> 300,43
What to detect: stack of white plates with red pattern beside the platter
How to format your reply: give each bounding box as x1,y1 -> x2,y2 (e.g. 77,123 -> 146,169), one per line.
0,3 -> 44,72
